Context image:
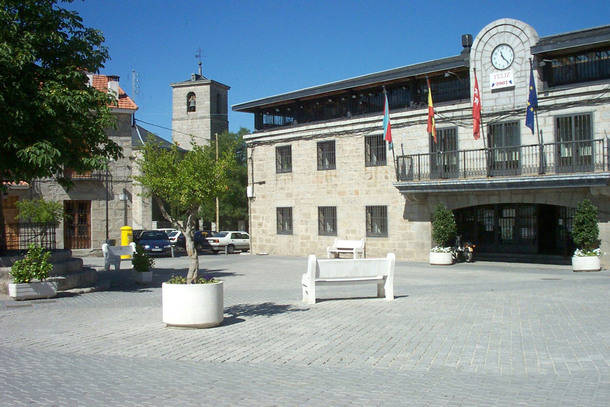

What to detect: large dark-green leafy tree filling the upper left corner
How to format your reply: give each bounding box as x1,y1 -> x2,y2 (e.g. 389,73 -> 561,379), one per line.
0,0 -> 121,249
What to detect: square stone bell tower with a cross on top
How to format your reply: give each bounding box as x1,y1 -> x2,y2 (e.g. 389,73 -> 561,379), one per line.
170,53 -> 230,150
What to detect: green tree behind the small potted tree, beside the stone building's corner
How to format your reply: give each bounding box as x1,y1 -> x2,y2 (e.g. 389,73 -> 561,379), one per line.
200,127 -> 250,230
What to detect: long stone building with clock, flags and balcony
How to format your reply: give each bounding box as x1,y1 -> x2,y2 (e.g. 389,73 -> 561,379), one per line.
233,19 -> 610,267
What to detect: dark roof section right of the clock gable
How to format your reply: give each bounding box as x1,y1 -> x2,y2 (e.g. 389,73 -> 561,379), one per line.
531,25 -> 610,55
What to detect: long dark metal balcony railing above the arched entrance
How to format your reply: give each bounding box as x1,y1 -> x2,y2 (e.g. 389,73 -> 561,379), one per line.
396,139 -> 610,181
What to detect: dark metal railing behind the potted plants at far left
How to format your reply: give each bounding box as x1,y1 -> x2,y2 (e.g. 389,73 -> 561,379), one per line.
0,223 -> 57,251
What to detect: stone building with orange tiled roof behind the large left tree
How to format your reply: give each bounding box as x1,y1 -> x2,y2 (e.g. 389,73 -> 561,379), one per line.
3,74 -> 162,249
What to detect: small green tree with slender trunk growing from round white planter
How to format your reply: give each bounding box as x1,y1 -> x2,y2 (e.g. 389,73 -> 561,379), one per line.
135,143 -> 235,283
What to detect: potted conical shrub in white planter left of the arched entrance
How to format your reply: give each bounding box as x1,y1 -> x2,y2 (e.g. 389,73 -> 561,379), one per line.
430,204 -> 457,265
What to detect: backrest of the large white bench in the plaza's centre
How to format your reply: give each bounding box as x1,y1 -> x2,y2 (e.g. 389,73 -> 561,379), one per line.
308,253 -> 395,278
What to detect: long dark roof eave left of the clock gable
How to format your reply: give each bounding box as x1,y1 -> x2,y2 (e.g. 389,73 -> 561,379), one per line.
232,54 -> 469,112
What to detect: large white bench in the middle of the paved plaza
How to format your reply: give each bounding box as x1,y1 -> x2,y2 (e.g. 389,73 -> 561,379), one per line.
301,253 -> 396,304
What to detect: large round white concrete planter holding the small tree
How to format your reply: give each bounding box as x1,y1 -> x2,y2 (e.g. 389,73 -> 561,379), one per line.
161,281 -> 224,328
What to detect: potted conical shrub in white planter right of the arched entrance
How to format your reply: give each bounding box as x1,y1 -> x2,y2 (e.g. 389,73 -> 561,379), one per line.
572,199 -> 601,271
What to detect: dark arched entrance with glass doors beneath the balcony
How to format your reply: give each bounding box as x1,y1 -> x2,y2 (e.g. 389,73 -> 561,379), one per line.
454,203 -> 574,258
